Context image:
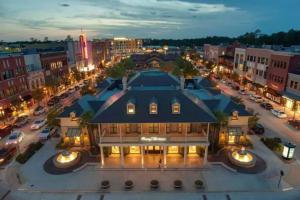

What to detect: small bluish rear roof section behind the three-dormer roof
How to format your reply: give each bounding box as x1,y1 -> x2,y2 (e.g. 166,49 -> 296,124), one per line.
128,71 -> 180,87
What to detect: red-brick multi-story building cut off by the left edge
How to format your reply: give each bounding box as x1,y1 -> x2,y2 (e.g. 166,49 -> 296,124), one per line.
0,54 -> 30,115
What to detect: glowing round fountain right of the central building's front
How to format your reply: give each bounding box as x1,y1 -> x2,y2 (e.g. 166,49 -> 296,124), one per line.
228,147 -> 256,168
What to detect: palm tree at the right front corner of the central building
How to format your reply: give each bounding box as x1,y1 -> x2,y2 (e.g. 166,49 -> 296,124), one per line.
211,111 -> 228,151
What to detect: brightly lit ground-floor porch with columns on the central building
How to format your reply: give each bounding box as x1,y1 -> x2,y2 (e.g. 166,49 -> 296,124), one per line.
100,145 -> 207,169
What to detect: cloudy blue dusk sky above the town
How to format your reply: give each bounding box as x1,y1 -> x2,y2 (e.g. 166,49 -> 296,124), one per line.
0,0 -> 300,41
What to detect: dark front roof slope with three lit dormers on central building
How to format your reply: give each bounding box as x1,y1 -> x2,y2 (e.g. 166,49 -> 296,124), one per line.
91,90 -> 215,123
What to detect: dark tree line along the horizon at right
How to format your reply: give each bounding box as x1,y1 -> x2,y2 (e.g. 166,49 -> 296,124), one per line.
144,29 -> 300,47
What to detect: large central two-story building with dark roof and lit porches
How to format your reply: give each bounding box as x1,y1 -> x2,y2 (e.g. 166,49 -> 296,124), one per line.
59,71 -> 250,168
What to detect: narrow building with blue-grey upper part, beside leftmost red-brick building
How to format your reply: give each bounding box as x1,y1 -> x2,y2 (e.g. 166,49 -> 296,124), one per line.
24,53 -> 45,91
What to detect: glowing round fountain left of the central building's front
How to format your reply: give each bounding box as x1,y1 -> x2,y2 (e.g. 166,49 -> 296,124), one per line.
53,150 -> 80,168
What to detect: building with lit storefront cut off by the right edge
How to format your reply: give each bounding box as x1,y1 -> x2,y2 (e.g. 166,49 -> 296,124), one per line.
283,68 -> 300,114
